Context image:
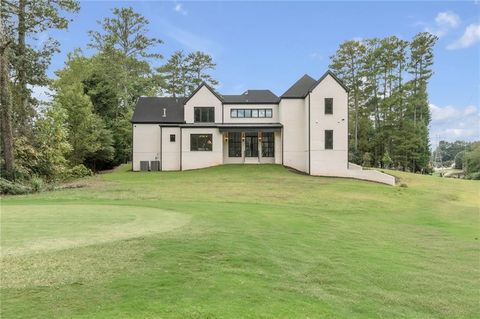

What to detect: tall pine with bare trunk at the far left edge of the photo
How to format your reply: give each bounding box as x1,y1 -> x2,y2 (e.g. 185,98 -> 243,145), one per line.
0,0 -> 78,178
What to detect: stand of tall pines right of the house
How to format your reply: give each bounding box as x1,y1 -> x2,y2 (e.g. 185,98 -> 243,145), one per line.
330,32 -> 438,172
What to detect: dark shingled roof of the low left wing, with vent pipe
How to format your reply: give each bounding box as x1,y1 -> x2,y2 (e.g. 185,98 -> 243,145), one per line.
131,97 -> 186,123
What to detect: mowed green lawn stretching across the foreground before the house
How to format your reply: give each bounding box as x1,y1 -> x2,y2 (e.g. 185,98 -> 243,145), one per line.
0,165 -> 480,318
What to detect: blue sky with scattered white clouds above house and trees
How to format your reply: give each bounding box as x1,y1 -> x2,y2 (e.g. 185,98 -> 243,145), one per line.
34,1 -> 480,146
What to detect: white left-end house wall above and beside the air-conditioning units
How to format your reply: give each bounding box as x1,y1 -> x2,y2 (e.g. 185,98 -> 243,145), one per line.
132,124 -> 160,171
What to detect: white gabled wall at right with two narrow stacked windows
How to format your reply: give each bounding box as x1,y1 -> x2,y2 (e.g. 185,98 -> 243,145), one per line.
310,75 -> 348,176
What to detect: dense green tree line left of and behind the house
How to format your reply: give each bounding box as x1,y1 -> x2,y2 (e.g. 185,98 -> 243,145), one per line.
0,0 -> 218,190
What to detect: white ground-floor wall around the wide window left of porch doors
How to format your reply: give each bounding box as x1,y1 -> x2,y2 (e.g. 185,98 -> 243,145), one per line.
182,128 -> 223,170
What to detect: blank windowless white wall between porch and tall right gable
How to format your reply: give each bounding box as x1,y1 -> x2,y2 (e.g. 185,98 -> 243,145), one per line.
279,99 -> 308,172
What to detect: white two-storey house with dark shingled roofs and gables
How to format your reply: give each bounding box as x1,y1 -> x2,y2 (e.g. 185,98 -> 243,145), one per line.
132,71 -> 395,185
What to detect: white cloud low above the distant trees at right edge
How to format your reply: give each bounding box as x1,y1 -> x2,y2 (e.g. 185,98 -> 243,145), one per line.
430,104 -> 480,144
